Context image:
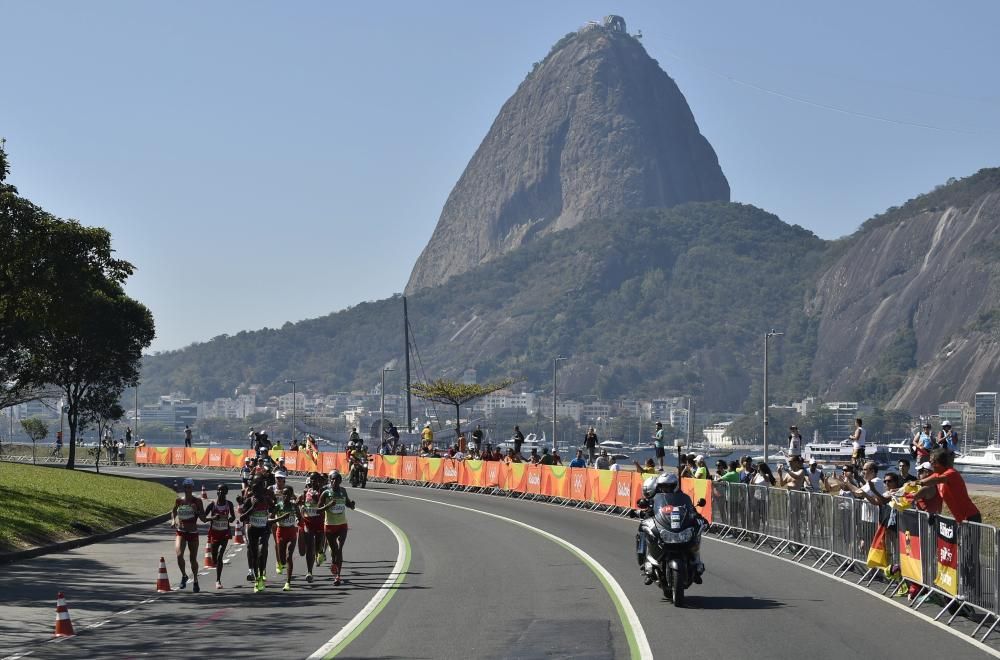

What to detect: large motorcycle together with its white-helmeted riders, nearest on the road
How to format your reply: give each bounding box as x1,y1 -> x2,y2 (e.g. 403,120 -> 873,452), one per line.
635,474 -> 708,607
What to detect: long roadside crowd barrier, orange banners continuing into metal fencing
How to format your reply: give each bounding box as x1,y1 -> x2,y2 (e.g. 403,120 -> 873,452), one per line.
135,447 -> 1000,640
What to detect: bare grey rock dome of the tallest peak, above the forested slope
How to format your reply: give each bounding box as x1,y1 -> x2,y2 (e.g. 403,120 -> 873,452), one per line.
406,16 -> 729,293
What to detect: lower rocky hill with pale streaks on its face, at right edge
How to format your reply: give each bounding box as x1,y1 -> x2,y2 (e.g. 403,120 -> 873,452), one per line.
805,169 -> 1000,411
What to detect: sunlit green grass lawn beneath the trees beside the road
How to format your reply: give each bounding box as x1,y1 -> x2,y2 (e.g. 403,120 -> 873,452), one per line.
0,463 -> 176,552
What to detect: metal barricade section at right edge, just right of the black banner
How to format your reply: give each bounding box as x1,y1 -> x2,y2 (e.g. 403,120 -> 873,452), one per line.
958,522 -> 1000,613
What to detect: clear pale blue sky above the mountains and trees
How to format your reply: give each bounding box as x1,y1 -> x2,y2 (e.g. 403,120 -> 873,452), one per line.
0,0 -> 1000,350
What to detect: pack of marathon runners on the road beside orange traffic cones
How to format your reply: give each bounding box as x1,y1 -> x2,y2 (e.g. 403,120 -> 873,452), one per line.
171,467 -> 355,593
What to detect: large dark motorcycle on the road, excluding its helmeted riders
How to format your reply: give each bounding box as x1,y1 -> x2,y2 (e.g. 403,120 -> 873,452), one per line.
635,499 -> 706,607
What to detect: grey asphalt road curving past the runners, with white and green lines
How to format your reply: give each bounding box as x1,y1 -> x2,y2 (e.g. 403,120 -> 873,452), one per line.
0,468 -> 987,660
